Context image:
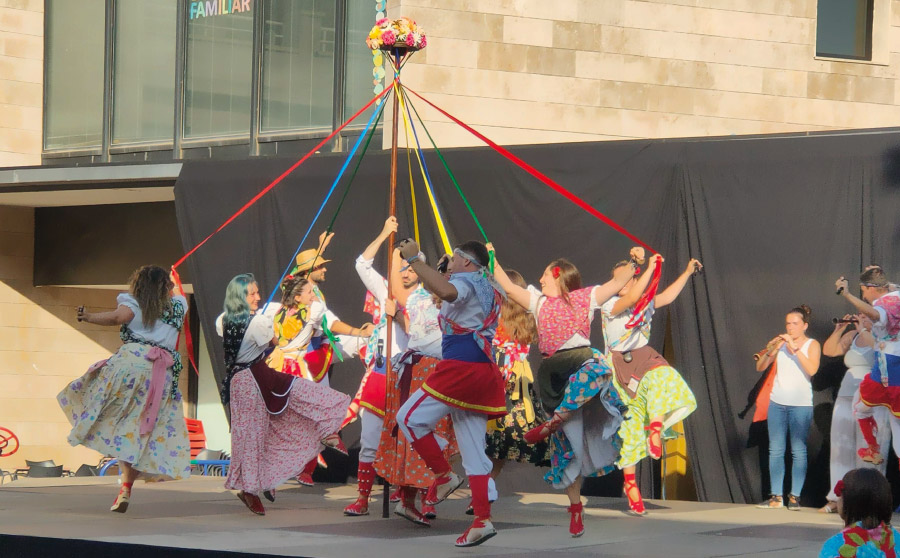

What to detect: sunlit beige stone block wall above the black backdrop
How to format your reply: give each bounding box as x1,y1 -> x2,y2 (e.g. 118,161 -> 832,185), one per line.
394,0 -> 900,146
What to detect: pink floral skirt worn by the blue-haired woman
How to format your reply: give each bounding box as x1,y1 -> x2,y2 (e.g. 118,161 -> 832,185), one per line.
225,370 -> 350,494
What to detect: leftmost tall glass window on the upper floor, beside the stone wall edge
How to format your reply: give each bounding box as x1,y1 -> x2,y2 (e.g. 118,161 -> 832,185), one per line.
44,0 -> 106,149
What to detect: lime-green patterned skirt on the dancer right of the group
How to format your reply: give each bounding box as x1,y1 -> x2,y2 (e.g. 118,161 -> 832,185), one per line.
614,366 -> 697,469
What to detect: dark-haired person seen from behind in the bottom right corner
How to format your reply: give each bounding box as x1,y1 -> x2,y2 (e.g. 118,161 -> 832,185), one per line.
819,469 -> 900,558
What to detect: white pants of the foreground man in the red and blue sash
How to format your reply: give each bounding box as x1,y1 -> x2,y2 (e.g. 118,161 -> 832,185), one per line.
397,389 -> 493,475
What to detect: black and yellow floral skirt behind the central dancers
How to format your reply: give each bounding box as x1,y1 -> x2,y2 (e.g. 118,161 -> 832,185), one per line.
485,360 -> 550,467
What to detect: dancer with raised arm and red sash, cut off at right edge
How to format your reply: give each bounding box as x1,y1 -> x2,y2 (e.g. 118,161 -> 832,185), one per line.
835,266 -> 900,470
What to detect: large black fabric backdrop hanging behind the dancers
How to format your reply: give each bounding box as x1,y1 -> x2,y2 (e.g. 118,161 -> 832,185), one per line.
175,133 -> 900,505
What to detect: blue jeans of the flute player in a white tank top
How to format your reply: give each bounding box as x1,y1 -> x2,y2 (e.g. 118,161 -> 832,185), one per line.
768,402 -> 812,498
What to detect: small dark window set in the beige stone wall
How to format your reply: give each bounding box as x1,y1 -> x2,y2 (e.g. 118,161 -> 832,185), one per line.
816,0 -> 874,60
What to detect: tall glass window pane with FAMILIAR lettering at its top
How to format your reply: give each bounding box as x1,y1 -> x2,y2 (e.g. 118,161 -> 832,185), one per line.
184,0 -> 253,138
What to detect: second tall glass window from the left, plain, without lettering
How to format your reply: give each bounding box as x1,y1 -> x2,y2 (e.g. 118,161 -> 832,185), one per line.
112,0 -> 178,143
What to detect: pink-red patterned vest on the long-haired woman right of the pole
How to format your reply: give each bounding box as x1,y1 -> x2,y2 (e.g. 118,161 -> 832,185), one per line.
537,287 -> 594,357
